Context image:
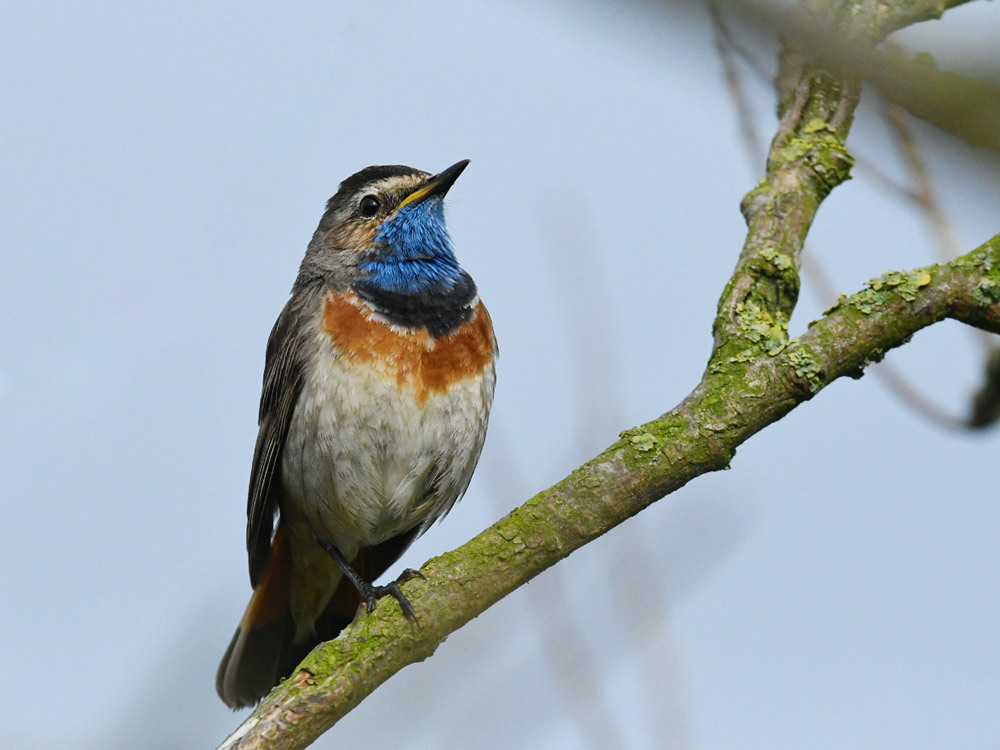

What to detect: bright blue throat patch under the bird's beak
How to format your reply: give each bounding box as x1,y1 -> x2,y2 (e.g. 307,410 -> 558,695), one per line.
361,197 -> 467,294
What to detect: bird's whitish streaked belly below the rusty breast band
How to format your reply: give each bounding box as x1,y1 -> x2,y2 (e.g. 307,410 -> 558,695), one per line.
282,336 -> 495,559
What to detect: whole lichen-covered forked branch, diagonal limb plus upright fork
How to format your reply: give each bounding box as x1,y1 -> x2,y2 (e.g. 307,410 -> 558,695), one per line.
220,0 -> 1000,750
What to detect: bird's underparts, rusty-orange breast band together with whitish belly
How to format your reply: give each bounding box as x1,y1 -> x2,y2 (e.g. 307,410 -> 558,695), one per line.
282,293 -> 496,558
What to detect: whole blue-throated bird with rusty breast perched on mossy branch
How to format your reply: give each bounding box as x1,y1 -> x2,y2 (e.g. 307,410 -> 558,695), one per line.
216,160 -> 498,709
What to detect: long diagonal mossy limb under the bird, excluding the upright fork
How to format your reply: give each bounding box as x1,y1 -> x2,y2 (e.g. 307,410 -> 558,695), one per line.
223,235 -> 1000,749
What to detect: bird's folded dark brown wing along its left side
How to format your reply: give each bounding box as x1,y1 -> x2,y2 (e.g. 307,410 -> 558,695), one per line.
247,296 -> 304,587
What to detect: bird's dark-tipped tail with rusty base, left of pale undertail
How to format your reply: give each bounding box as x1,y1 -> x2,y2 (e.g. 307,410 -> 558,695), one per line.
215,526 -> 315,708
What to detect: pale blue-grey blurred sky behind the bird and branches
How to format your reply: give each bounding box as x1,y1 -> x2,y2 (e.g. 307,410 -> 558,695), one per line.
0,0 -> 1000,750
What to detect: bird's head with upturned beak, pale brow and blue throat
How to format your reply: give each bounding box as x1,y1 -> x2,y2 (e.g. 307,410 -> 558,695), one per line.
303,160 -> 471,295
